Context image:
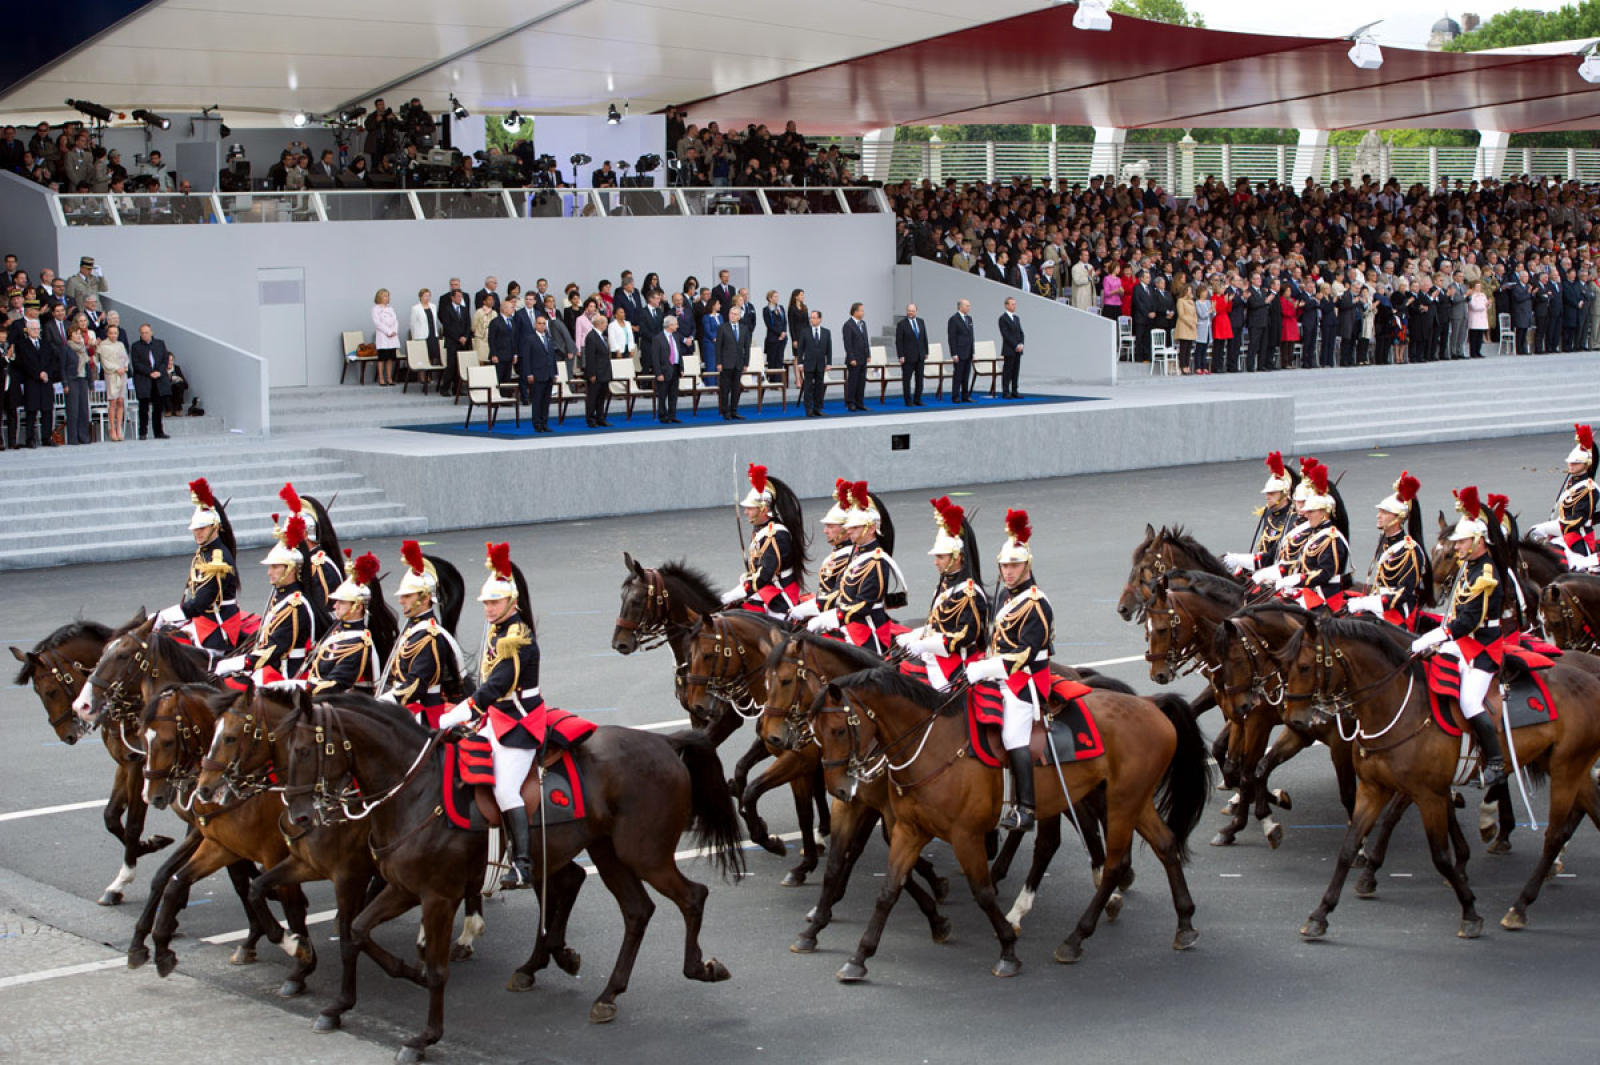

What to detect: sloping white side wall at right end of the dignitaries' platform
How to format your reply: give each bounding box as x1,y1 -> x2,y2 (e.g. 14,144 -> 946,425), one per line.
896,259 -> 1117,392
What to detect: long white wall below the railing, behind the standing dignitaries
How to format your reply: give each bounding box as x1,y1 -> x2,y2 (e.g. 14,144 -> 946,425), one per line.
53,214 -> 902,385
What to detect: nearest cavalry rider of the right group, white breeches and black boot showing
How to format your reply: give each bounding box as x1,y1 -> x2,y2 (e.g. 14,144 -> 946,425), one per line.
1411,486 -> 1507,788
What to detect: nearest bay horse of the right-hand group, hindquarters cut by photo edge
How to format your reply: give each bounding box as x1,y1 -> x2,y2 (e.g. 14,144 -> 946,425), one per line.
1280,616 -> 1600,939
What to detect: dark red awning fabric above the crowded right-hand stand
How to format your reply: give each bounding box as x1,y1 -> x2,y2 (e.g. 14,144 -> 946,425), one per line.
690,5 -> 1600,133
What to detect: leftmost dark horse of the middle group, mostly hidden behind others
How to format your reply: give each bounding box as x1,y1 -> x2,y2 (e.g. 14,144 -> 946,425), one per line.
611,552 -> 829,836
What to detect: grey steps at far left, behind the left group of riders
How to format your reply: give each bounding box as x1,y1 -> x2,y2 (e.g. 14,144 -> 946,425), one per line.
0,437 -> 427,569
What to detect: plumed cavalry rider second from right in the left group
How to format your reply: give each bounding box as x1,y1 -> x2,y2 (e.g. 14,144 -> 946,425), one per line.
378,540 -> 462,729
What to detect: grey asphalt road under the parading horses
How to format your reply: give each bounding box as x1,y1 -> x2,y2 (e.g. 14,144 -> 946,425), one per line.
0,437 -> 1600,1065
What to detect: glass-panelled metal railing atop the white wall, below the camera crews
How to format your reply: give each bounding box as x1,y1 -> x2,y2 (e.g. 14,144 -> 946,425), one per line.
56,187 -> 890,225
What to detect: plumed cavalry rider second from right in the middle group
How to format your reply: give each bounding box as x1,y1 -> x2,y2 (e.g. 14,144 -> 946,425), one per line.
894,496 -> 989,691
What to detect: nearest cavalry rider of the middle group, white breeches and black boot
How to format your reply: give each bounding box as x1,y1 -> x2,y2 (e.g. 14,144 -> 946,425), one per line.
966,510 -> 1056,832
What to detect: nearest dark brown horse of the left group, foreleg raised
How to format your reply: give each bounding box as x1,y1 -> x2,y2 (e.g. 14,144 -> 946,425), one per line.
283,694 -> 742,1062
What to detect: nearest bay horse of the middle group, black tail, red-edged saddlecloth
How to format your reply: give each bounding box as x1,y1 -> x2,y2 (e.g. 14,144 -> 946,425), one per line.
797,633 -> 1211,983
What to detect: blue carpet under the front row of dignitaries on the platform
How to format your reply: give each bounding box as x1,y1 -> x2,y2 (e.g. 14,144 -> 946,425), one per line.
390,390 -> 1096,440
